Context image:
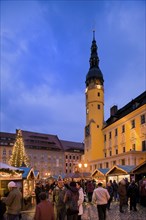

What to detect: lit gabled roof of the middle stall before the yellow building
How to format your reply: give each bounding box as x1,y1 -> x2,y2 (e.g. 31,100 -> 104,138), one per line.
106,165 -> 135,175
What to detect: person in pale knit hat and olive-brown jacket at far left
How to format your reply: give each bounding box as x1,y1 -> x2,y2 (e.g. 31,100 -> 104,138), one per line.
3,181 -> 22,220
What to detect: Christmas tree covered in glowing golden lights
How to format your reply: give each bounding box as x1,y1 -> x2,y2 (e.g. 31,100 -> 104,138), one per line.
9,130 -> 29,167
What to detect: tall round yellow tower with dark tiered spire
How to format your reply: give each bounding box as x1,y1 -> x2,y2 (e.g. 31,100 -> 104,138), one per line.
85,31 -> 104,164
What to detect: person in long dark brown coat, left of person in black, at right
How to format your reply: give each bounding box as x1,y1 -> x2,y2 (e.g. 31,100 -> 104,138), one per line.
118,179 -> 127,213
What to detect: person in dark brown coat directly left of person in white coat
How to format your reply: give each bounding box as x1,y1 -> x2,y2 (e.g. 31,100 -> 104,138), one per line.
64,182 -> 79,220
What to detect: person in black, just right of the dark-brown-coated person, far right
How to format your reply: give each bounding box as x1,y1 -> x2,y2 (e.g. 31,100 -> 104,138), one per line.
127,180 -> 139,211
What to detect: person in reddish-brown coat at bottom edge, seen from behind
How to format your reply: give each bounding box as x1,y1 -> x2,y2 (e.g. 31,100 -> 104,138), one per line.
34,192 -> 55,220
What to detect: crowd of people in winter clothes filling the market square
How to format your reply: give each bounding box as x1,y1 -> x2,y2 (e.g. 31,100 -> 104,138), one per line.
0,178 -> 146,220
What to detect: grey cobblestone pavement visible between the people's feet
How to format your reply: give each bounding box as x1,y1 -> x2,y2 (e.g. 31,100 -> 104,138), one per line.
22,202 -> 146,220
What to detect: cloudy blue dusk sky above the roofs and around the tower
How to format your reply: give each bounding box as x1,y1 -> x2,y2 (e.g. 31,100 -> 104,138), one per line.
0,0 -> 146,142
